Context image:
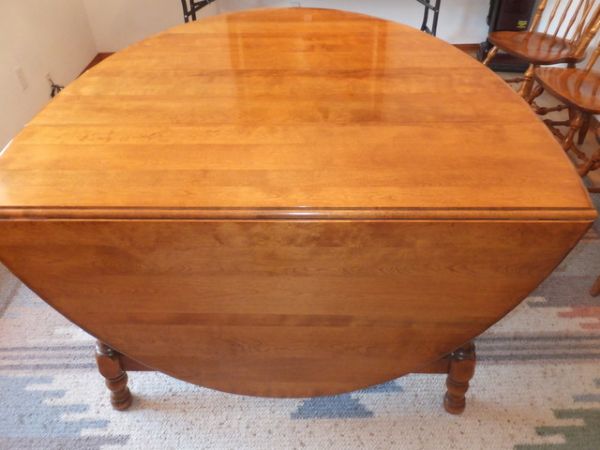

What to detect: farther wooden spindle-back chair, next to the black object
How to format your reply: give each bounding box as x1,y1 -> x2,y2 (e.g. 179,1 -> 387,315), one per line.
483,0 -> 600,100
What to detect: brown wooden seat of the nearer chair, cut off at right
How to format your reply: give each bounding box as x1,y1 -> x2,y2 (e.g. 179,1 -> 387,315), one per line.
534,67 -> 600,114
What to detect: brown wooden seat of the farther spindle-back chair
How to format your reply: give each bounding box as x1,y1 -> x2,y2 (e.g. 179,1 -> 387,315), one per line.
488,31 -> 582,65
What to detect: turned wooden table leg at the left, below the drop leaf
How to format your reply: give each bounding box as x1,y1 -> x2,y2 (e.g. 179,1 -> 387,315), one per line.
96,341 -> 132,411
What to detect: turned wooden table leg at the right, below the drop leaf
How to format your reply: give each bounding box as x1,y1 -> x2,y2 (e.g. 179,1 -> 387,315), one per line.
444,342 -> 476,414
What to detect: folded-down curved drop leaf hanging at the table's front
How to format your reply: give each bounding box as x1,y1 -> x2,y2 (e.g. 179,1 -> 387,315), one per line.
0,220 -> 589,397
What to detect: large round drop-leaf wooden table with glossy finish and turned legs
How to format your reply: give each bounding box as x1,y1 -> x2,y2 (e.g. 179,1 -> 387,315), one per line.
0,8 -> 596,413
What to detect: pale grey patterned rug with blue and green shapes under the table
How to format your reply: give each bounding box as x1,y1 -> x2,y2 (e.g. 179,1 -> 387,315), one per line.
0,204 -> 600,450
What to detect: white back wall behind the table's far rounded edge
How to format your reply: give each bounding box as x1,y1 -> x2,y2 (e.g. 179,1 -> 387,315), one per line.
83,0 -> 489,52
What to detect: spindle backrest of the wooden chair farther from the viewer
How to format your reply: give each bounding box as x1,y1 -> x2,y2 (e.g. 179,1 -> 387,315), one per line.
529,0 -> 600,57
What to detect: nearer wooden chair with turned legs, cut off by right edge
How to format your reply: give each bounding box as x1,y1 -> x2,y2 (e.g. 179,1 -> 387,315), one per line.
533,46 -> 600,172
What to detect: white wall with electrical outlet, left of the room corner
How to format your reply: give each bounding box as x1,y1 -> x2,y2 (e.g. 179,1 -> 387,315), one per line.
0,0 -> 97,148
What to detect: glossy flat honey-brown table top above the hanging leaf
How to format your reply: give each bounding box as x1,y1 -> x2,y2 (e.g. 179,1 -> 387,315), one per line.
0,9 -> 592,218
